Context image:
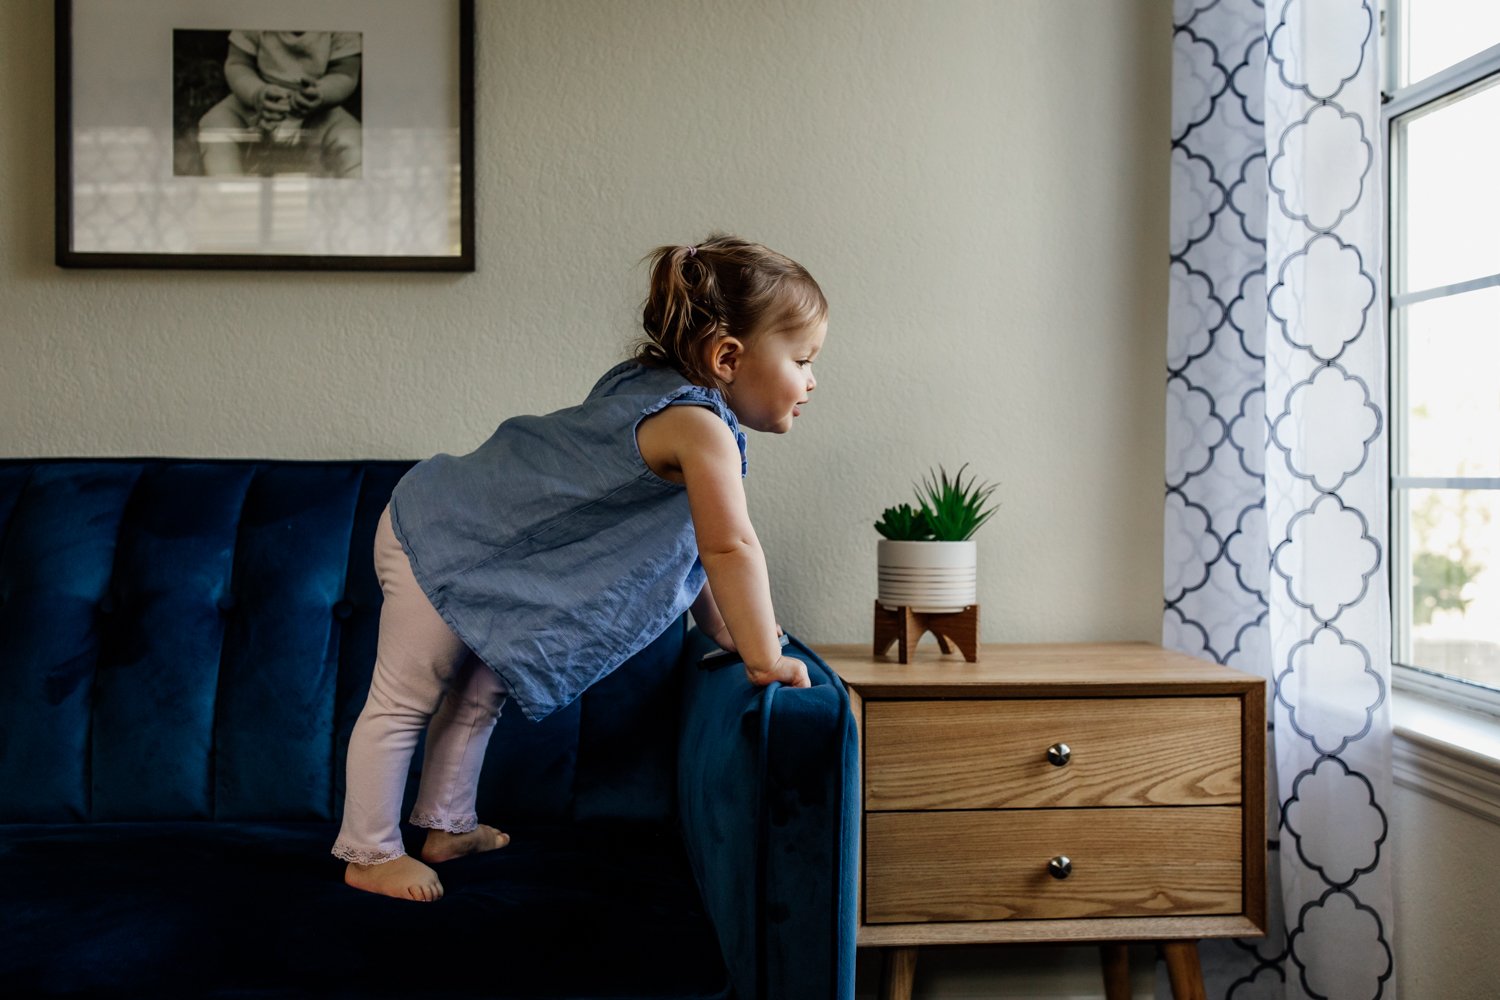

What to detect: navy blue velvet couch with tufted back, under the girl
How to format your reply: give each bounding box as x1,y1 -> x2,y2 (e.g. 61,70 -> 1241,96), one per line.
0,459 -> 858,1000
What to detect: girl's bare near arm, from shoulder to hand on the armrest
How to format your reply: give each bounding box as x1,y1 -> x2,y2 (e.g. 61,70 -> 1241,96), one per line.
638,406 -> 809,688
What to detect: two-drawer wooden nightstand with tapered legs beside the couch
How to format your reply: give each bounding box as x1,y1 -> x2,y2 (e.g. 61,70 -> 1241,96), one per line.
818,643 -> 1266,1000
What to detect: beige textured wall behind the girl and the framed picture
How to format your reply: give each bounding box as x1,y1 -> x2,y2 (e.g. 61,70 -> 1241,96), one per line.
11,0 -> 1172,996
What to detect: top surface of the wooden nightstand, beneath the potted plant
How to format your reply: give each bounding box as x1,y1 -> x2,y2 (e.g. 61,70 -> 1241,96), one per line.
812,637 -> 1265,697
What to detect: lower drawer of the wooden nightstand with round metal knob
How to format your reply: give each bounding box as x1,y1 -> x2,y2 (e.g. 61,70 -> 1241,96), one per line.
864,807 -> 1242,924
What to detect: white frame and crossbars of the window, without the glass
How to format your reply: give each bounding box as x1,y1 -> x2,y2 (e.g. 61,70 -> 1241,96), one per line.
1380,0 -> 1500,726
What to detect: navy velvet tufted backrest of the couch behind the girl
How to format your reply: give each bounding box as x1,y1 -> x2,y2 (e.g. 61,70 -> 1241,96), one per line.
0,459 -> 686,823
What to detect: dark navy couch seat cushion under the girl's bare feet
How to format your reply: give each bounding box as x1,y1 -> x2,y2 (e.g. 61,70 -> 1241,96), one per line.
0,822 -> 729,999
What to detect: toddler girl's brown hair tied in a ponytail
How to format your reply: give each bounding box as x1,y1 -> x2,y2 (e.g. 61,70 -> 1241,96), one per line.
635,232 -> 828,388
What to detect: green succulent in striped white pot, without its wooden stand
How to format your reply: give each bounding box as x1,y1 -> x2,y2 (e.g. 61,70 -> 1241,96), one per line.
875,465 -> 995,613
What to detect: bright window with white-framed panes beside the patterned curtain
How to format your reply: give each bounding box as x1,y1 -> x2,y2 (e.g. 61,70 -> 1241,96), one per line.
1382,0 -> 1500,711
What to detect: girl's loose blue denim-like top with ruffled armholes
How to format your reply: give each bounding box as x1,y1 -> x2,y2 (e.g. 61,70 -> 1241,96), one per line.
390,361 -> 746,720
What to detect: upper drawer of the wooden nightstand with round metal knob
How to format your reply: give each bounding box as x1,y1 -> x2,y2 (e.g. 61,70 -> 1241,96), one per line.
863,697 -> 1241,810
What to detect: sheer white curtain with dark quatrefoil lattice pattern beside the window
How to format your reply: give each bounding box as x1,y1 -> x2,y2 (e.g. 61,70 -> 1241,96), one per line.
1163,0 -> 1395,1000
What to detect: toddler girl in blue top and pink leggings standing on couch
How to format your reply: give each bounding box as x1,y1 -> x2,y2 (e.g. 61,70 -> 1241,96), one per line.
333,235 -> 828,901
